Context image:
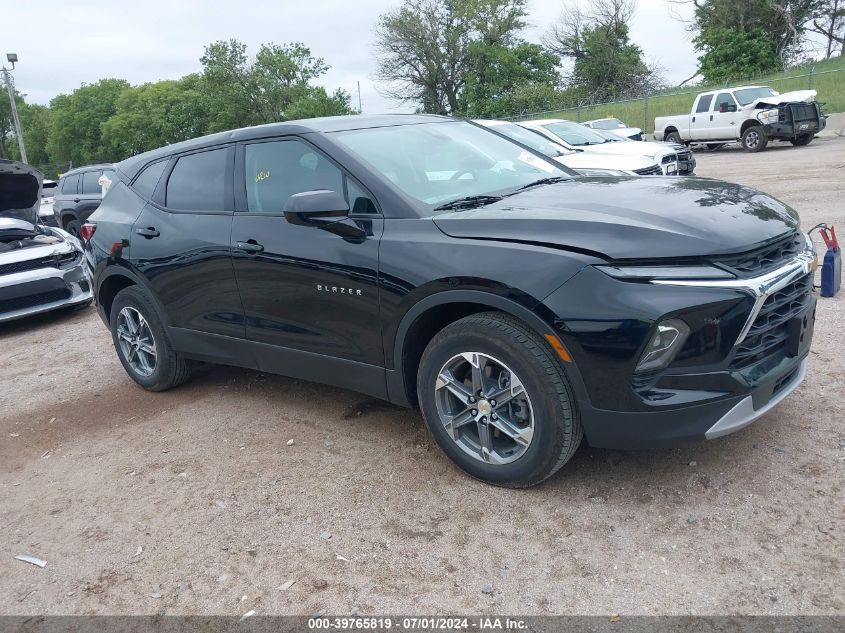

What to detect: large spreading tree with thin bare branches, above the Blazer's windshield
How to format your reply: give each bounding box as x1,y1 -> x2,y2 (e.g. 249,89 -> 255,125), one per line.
375,0 -> 532,114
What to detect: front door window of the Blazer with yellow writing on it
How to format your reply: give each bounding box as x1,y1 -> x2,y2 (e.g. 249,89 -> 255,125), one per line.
244,141 -> 344,213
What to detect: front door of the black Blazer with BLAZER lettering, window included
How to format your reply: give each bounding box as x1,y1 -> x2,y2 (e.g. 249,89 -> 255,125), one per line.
231,137 -> 384,370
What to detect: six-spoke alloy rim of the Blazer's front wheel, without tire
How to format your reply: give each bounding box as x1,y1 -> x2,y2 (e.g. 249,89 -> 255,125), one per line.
434,352 -> 534,465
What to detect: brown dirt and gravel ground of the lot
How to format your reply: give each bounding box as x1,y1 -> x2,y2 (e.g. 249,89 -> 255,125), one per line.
0,138 -> 845,615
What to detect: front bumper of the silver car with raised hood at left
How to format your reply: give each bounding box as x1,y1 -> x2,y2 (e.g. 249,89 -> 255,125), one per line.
0,259 -> 93,322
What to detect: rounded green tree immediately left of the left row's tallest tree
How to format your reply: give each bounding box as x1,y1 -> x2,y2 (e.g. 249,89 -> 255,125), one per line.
101,74 -> 209,157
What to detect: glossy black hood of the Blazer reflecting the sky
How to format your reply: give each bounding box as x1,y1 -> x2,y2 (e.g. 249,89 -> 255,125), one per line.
434,176 -> 798,260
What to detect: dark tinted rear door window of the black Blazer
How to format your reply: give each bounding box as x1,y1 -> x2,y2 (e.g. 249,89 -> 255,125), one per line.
166,148 -> 229,211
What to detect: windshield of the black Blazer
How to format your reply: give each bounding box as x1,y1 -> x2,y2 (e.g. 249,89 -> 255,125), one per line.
333,121 -> 570,205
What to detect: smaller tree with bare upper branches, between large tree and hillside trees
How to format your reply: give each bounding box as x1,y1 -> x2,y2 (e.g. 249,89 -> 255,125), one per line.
545,0 -> 662,101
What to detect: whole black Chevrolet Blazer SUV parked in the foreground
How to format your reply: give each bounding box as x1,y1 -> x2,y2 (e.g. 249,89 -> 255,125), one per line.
83,115 -> 815,486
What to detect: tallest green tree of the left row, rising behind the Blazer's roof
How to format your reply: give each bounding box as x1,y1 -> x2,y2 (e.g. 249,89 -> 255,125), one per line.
200,40 -> 354,131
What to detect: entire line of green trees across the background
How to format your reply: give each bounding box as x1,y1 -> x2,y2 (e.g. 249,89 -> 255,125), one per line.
0,0 -> 845,176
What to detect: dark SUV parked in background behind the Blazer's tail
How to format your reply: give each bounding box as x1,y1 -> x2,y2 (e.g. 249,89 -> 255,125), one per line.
53,165 -> 114,237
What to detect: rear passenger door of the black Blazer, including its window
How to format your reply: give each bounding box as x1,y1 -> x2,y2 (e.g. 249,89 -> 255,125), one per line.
129,145 -> 246,346
